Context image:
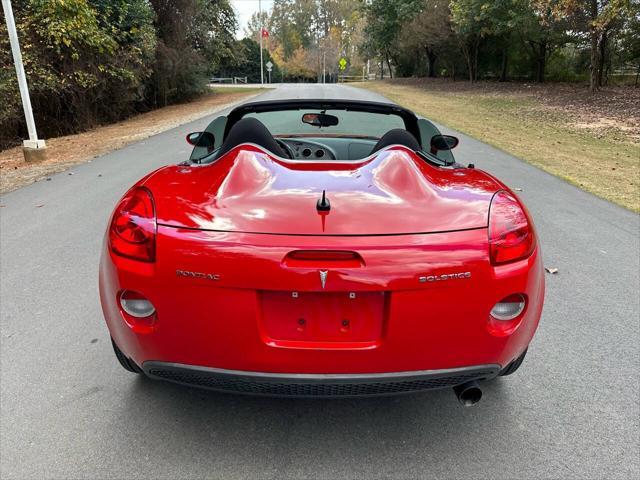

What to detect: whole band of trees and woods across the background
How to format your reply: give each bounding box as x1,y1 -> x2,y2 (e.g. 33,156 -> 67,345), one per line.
0,0 -> 640,149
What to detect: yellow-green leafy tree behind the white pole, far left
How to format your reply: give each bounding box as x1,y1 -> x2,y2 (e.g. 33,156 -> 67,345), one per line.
0,0 -> 156,148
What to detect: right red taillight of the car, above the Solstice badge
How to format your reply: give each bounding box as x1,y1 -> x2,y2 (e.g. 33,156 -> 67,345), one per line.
489,192 -> 535,265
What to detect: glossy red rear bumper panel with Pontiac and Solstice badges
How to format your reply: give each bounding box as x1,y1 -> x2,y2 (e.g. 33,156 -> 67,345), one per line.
100,227 -> 544,376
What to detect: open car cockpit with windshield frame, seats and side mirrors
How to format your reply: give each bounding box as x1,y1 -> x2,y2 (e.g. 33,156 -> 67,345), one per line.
187,102 -> 457,165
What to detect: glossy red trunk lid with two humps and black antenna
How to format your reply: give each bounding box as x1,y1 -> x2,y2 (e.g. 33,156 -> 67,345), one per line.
145,145 -> 501,235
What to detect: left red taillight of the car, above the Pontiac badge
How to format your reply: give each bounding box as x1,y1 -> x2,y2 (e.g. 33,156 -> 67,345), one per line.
109,187 -> 156,262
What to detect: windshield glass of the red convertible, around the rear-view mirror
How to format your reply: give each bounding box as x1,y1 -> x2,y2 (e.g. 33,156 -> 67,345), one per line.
243,109 -> 405,139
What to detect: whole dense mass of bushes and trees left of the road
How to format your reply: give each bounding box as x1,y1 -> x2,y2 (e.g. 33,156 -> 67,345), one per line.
0,0 -> 235,149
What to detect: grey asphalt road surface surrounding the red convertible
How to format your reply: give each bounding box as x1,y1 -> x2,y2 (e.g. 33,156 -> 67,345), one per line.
0,85 -> 640,479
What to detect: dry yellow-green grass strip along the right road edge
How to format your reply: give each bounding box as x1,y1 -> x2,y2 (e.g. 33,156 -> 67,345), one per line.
362,82 -> 640,212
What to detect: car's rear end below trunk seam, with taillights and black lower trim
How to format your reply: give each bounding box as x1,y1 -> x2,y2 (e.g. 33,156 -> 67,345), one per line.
100,148 -> 544,396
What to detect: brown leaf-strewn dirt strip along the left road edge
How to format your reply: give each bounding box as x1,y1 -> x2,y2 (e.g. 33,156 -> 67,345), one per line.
0,89 -> 264,193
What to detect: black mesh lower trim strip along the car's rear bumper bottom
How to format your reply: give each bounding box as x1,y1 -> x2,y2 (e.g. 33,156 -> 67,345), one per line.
142,361 -> 500,398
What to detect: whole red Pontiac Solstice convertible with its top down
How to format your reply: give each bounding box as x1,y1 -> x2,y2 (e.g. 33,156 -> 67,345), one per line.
100,100 -> 544,405
